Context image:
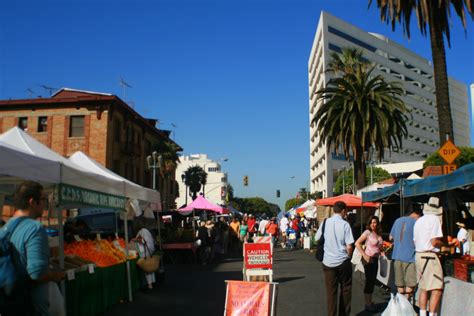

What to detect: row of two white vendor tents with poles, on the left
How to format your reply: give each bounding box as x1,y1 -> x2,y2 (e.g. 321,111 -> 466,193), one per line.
0,127 -> 161,300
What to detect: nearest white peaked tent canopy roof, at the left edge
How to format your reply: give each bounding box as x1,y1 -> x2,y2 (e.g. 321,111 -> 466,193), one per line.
0,127 -> 125,196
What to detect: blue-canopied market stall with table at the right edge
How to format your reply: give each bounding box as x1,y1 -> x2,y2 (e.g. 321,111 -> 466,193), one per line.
362,163 -> 474,315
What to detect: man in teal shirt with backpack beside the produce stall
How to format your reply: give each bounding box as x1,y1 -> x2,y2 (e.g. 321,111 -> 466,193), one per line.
0,181 -> 65,316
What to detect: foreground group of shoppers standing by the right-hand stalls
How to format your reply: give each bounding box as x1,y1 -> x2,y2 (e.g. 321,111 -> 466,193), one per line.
315,197 -> 469,316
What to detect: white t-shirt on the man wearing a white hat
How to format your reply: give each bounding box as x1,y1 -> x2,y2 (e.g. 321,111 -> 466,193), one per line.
413,214 -> 443,252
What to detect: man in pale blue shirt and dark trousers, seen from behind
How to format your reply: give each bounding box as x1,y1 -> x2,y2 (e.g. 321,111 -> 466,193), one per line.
316,201 -> 354,316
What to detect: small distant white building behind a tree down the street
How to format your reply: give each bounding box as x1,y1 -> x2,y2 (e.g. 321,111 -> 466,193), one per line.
176,154 -> 228,208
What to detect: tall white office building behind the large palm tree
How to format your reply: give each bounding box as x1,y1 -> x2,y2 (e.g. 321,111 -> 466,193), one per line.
308,12 -> 470,196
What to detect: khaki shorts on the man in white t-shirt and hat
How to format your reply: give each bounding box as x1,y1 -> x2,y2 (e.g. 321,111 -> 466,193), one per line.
415,252 -> 444,291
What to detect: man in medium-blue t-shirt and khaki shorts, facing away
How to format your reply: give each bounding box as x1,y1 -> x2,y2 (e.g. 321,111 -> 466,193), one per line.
390,209 -> 421,301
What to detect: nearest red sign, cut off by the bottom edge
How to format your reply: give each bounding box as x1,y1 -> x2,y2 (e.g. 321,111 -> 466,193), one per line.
225,281 -> 270,316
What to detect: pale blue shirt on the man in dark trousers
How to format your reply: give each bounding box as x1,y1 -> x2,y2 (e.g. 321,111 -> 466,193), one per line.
316,214 -> 354,267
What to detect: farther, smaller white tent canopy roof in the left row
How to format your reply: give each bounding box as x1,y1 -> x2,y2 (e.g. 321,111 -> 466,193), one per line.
69,151 -> 161,207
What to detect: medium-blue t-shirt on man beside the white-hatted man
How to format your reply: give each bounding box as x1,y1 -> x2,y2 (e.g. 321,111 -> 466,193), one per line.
390,216 -> 416,262
